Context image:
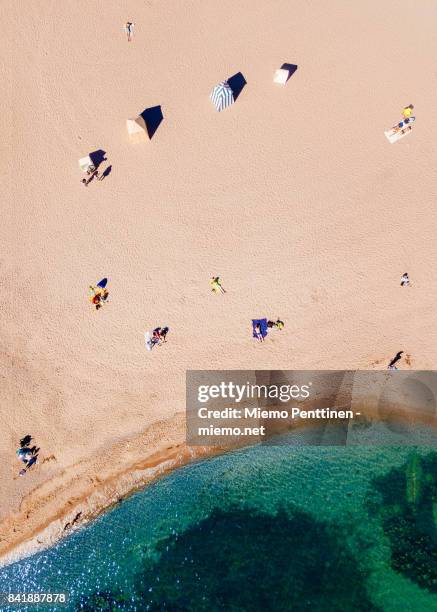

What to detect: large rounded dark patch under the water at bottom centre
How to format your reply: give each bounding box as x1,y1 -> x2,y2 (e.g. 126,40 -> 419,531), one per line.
77,507 -> 379,612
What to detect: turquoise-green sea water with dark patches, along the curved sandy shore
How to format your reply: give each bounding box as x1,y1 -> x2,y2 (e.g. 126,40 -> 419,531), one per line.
0,438 -> 437,612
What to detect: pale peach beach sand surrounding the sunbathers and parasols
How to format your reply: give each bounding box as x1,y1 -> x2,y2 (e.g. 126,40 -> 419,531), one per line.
0,0 -> 437,554
